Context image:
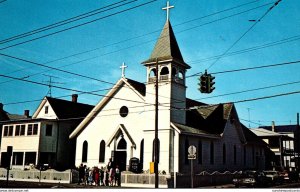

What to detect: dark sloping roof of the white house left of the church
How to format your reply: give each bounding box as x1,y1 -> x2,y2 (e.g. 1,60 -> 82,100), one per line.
46,97 -> 94,119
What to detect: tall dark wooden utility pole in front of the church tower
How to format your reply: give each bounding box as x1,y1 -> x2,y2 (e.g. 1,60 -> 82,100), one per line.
154,58 -> 159,188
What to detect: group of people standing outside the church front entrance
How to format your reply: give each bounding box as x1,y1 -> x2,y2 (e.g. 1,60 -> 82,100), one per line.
78,159 -> 121,186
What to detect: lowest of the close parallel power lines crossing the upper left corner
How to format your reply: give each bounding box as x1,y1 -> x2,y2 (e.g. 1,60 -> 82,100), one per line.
0,0 -> 157,50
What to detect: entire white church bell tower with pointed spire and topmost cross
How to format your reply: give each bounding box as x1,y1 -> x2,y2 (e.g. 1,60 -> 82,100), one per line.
142,2 -> 190,173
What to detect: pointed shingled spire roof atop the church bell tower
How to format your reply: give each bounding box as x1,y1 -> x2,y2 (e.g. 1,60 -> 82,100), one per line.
143,20 -> 190,68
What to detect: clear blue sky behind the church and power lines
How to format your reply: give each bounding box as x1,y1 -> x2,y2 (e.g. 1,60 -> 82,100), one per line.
0,0 -> 300,127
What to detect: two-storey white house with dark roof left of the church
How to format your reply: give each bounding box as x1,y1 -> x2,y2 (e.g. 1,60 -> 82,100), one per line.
0,95 -> 93,169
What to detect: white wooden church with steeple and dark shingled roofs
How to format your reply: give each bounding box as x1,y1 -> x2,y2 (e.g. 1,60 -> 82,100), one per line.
69,4 -> 266,174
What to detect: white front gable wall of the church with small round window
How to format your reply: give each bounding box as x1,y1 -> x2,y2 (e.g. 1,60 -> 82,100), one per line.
76,84 -> 147,166
